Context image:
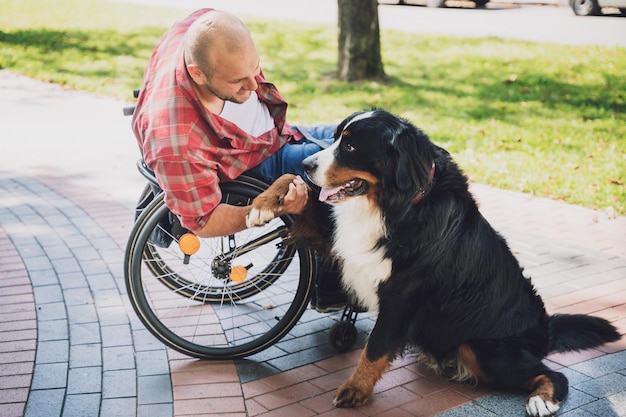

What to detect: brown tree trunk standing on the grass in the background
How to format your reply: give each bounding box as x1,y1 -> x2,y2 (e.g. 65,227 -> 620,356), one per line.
337,0 -> 385,81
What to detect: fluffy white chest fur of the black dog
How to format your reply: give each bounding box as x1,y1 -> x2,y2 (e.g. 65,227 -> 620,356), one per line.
333,197 -> 391,311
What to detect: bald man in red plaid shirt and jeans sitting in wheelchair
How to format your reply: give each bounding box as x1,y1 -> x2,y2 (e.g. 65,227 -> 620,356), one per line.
132,9 -> 346,312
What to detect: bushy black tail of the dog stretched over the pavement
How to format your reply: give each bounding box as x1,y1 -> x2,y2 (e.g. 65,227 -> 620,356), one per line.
549,314 -> 621,352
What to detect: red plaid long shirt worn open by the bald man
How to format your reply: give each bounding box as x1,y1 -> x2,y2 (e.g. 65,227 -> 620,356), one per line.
132,9 -> 301,230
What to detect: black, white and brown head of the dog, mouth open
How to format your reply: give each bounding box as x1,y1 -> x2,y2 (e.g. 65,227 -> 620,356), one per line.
303,110 -> 433,214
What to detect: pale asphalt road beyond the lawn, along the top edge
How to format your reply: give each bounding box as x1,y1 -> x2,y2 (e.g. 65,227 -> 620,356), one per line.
109,0 -> 626,47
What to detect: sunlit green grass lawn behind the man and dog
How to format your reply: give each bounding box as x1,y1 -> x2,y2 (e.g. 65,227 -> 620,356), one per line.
0,0 -> 626,215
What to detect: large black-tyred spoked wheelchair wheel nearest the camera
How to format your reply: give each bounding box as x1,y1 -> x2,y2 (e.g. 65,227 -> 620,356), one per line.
124,178 -> 315,359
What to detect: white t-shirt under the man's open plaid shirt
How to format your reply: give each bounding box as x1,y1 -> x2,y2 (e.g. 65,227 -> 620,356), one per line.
220,91 -> 275,136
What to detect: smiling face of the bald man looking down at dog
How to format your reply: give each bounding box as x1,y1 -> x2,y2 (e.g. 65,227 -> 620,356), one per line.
201,45 -> 261,103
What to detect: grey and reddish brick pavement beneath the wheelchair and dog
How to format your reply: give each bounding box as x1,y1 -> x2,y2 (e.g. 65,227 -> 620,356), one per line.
0,70 -> 626,417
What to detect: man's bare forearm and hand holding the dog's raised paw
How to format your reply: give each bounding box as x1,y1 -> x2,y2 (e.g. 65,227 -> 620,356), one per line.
194,177 -> 308,237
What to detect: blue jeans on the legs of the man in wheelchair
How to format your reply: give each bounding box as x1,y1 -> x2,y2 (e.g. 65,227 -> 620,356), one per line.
247,125 -> 336,185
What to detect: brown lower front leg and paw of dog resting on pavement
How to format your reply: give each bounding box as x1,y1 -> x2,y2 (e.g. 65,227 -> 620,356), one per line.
333,345 -> 393,407
